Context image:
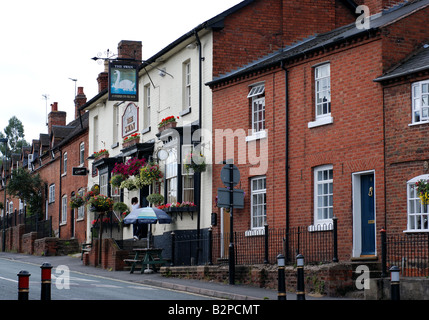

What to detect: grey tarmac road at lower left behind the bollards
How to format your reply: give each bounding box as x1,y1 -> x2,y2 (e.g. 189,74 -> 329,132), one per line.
0,258 -> 214,300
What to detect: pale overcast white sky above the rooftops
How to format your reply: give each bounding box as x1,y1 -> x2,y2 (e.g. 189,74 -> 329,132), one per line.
0,0 -> 242,144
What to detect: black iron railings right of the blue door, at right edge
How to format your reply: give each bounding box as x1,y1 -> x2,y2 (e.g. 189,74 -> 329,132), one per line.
381,231 -> 429,277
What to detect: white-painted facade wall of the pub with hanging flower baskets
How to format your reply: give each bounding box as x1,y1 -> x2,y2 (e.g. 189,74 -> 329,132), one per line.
85,30 -> 213,239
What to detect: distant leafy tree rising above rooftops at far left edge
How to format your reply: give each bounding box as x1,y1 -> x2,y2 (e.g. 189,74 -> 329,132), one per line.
0,116 -> 28,157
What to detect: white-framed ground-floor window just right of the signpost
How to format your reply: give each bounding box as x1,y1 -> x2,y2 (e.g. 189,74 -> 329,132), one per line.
250,176 -> 267,230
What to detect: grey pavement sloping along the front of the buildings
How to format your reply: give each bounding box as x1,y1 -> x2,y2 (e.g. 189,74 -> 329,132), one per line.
0,252 -> 356,300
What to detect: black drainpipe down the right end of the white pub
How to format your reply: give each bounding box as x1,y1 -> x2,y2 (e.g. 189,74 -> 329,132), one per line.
194,29 -> 203,264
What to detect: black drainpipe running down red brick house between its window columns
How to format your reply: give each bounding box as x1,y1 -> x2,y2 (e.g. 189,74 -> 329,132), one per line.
281,61 -> 290,261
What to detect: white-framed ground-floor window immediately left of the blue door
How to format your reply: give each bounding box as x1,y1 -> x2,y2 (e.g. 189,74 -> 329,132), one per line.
313,165 -> 334,226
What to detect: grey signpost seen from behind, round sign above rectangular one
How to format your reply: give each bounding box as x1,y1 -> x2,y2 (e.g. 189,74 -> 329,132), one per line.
218,163 -> 244,284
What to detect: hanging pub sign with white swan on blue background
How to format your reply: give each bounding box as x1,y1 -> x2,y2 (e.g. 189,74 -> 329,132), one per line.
109,61 -> 138,101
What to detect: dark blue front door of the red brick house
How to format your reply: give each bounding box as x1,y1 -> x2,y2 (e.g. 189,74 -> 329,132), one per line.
361,174 -> 375,255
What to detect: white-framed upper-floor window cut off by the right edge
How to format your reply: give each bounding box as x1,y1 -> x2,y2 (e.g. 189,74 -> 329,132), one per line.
411,80 -> 429,124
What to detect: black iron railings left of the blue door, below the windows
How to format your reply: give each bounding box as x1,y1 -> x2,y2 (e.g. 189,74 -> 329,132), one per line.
172,220 -> 338,265
